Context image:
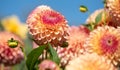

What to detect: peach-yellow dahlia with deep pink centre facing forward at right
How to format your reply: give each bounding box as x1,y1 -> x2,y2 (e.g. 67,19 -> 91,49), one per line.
84,26 -> 120,65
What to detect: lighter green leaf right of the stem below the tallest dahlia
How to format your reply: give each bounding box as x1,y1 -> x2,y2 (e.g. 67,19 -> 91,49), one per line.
48,43 -> 60,65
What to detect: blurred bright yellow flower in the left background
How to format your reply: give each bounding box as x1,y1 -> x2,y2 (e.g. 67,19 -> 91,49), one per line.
1,15 -> 28,39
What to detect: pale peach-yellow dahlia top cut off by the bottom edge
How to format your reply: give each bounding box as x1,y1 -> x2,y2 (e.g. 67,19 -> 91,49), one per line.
66,53 -> 117,70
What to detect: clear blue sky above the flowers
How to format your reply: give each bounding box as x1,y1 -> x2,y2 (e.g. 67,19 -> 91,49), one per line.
0,0 -> 103,25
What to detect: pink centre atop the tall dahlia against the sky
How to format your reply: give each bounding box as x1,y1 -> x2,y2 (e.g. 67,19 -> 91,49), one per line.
42,10 -> 64,24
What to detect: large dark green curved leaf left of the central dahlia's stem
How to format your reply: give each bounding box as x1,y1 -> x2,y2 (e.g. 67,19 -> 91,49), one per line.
26,45 -> 46,70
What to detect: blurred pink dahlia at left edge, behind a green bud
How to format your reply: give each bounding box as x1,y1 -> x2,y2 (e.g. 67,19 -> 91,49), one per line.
0,32 -> 24,65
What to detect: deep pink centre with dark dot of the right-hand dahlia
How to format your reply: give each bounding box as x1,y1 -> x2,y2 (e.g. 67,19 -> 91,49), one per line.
100,34 -> 118,53
